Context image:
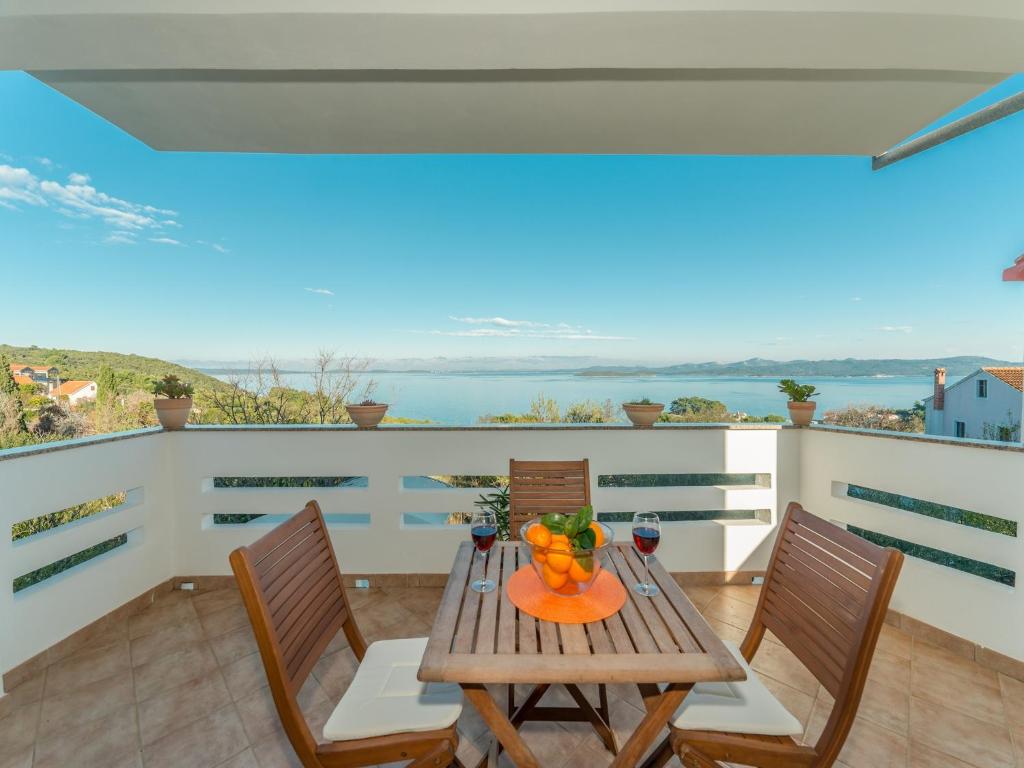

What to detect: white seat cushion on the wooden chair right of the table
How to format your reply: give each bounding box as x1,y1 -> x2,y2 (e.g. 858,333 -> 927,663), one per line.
673,642 -> 804,736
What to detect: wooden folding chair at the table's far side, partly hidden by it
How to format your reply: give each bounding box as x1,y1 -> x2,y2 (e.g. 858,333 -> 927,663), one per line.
497,459 -> 617,753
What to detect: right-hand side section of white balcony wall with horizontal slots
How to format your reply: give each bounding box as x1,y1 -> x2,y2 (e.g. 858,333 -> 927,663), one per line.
800,428 -> 1024,658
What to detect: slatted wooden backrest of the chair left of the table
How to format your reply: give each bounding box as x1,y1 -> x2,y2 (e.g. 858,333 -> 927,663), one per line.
230,502 -> 366,766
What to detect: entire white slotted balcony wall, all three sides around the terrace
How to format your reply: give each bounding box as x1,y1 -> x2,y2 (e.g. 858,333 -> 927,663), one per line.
0,426 -> 1024,688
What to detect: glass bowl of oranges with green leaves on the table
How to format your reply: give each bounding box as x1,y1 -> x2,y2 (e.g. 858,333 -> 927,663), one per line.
519,507 -> 613,597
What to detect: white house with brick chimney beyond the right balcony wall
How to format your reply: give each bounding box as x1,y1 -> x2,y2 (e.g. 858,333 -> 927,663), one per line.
925,367 -> 1024,442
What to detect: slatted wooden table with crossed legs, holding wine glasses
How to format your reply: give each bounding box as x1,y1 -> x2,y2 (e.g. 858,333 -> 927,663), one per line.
419,542 -> 745,768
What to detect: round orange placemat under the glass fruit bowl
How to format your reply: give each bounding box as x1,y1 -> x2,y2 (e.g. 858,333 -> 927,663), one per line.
506,565 -> 626,624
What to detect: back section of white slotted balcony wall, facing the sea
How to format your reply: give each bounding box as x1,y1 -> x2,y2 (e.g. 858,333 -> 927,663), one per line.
168,428 -> 799,574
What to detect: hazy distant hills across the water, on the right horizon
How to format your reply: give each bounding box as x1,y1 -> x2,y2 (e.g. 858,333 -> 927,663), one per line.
578,356 -> 1017,377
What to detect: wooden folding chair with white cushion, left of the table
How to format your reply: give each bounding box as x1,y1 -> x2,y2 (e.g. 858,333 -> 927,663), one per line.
230,502 -> 462,768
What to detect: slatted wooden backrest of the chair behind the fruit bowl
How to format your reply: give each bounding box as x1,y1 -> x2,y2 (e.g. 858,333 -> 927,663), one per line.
509,459 -> 590,539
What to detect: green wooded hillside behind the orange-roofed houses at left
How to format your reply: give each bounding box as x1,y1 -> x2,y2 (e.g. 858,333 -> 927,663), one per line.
0,344 -> 225,390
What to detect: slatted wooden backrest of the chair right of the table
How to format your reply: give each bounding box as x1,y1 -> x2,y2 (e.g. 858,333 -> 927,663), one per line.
742,503 -> 903,766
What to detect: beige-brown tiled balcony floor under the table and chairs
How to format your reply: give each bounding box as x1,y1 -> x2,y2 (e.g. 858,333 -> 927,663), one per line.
0,587 -> 1024,768
